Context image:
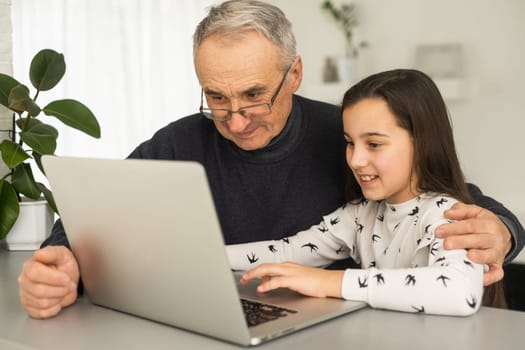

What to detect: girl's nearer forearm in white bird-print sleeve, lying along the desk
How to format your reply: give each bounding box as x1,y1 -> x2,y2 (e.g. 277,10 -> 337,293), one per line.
342,238 -> 483,316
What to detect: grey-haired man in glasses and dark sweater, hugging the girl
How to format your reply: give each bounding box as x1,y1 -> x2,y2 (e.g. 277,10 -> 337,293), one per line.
19,0 -> 525,318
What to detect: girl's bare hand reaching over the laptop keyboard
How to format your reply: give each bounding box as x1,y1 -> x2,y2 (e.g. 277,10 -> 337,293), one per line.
241,262 -> 344,298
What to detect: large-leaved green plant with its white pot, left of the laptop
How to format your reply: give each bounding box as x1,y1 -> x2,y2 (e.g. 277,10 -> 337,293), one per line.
0,49 -> 100,250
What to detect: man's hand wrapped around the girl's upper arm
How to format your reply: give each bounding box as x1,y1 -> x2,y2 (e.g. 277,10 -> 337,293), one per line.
436,203 -> 512,286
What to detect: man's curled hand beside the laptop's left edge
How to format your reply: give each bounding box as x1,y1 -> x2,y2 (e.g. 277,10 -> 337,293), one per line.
18,246 -> 80,318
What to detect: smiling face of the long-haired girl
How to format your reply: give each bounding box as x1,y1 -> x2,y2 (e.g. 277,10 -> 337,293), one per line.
343,98 -> 419,204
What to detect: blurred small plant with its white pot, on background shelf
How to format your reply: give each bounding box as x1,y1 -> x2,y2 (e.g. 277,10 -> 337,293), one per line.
321,0 -> 368,83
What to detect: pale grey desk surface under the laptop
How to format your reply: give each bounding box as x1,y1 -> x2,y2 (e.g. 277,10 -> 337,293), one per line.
0,248 -> 525,350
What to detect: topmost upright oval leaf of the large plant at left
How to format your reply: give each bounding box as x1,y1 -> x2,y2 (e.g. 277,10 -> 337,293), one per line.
29,49 -> 66,91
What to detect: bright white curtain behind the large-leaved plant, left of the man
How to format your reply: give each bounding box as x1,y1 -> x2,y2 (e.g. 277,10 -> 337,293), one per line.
12,0 -> 213,158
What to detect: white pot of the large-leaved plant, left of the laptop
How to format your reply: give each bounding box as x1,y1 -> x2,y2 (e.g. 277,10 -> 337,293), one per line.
5,200 -> 54,250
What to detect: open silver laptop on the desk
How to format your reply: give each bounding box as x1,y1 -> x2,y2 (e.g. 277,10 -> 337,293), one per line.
42,156 -> 366,346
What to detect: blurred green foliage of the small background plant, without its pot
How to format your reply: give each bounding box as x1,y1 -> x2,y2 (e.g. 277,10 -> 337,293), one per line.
321,0 -> 368,57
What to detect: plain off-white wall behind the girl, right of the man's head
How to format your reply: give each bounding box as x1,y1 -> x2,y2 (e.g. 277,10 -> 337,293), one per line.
268,0 -> 525,223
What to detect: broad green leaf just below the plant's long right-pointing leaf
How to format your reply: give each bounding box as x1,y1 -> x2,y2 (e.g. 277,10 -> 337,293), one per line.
17,118 -> 58,154
